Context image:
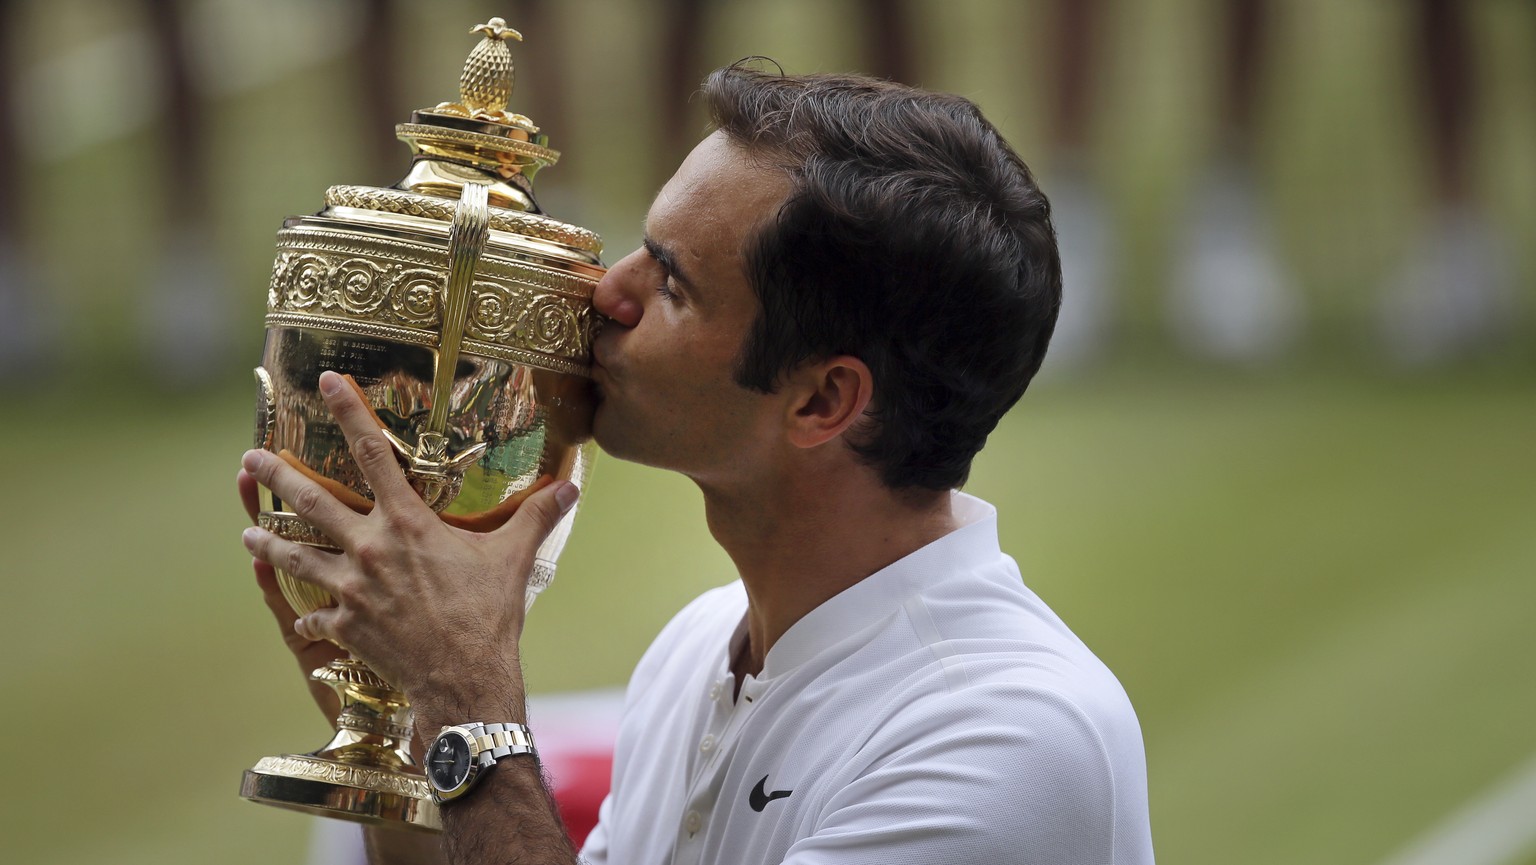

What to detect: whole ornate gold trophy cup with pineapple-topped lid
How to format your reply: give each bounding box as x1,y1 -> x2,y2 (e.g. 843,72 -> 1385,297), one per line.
240,18 -> 604,831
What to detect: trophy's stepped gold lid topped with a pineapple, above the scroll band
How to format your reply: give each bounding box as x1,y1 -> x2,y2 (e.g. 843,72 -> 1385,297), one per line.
321,18 -> 602,264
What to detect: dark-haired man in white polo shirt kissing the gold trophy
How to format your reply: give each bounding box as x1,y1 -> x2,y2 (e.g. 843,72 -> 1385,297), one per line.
241,68 -> 1152,865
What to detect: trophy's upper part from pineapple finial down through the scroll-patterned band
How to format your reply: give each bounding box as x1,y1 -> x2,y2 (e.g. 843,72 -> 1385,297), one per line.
266,18 -> 604,396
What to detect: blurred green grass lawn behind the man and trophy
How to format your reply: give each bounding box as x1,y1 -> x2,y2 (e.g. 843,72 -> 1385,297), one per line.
0,367 -> 1536,865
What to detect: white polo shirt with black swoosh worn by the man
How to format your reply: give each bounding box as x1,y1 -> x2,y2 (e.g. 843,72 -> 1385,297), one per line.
582,493 -> 1152,865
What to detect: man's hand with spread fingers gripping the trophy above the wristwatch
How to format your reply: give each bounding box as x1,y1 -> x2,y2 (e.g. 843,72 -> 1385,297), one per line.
241,372 -> 578,731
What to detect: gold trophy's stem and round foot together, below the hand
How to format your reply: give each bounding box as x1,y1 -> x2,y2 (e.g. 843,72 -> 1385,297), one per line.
240,658 -> 442,831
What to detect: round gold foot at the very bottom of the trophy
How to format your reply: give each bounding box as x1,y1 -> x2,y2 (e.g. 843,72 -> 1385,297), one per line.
240,754 -> 442,833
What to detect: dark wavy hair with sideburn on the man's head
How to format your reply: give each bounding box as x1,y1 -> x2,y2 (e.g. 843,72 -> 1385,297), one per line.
703,63 -> 1061,490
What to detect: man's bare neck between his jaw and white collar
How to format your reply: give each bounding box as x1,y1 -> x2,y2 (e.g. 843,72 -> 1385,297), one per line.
700,466 -> 957,682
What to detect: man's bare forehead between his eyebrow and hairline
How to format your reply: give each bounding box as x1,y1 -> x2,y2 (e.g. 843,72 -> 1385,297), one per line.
645,132 -> 790,266
